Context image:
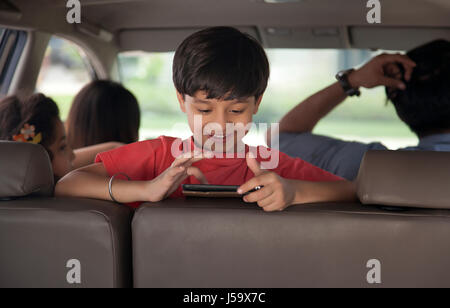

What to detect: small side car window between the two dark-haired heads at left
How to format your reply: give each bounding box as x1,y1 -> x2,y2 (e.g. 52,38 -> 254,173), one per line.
36,36 -> 92,120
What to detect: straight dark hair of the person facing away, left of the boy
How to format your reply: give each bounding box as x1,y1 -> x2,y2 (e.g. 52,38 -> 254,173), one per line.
67,80 -> 141,149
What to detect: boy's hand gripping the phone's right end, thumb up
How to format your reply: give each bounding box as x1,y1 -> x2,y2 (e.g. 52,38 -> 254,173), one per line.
238,154 -> 296,212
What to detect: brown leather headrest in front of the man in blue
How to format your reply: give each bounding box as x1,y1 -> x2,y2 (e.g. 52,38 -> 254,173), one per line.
357,151 -> 450,209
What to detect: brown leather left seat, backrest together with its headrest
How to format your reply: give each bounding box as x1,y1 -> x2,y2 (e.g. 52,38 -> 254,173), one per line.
0,142 -> 132,288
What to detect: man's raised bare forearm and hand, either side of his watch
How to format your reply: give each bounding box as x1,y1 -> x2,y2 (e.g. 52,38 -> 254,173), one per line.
276,54 -> 416,137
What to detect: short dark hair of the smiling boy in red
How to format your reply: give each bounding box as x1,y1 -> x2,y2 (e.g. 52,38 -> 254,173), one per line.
173,27 -> 270,100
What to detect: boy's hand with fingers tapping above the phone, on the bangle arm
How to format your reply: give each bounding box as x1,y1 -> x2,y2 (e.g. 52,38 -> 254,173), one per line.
145,153 -> 208,202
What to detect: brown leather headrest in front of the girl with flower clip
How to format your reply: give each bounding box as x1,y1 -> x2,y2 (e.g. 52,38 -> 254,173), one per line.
0,141 -> 54,199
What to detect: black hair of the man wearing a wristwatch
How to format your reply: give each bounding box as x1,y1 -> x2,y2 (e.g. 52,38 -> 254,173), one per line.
386,40 -> 450,137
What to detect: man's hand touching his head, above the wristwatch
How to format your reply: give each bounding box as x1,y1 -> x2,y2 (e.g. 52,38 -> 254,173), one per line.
349,54 -> 416,90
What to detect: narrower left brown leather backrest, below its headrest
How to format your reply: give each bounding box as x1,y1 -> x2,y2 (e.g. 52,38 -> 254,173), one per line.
0,198 -> 132,288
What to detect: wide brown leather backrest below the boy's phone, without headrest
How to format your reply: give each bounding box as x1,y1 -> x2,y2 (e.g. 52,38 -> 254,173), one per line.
133,199 -> 450,288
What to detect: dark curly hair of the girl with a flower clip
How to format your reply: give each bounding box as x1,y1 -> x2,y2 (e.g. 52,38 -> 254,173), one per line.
0,94 -> 59,159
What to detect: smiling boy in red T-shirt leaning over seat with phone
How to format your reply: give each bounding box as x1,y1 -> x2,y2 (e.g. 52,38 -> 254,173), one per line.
56,27 -> 356,212
